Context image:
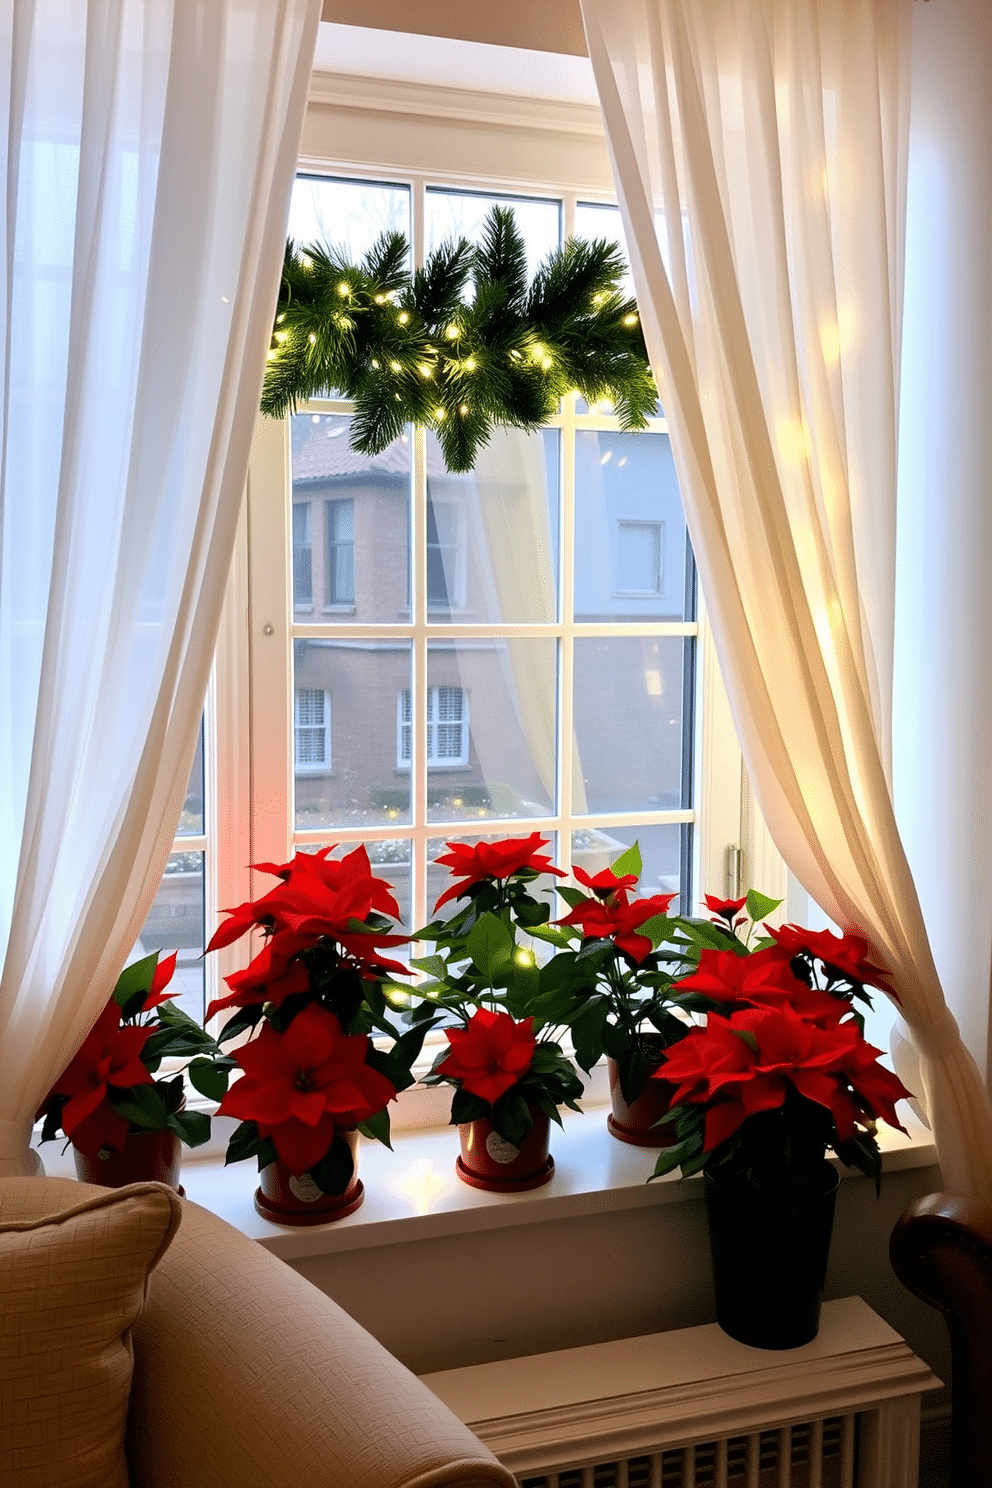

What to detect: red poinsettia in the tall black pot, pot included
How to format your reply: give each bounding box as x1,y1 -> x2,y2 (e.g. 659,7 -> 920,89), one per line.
653,921 -> 909,1348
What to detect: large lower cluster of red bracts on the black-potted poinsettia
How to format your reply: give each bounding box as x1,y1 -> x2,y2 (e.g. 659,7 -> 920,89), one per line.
657,1004 -> 909,1152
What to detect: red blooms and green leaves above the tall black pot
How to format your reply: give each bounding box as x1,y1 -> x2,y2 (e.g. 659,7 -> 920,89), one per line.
653,896 -> 910,1193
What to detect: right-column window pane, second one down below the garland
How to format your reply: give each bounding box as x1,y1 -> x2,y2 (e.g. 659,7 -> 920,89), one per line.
573,635 -> 686,812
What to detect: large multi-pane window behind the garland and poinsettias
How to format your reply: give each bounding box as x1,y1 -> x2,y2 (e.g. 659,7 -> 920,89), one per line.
250,176 -> 704,927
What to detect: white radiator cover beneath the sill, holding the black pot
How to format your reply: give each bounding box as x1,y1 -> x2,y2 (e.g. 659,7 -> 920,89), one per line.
422,1298 -> 940,1488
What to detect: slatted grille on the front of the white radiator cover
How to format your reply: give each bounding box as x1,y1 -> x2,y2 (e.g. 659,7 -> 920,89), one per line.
519,1415 -> 857,1488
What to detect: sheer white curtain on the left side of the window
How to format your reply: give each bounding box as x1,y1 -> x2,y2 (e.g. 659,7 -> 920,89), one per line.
0,0 -> 320,1173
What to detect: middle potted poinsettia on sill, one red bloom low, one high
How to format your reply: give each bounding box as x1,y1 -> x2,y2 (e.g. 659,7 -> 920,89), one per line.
409,832 -> 582,1192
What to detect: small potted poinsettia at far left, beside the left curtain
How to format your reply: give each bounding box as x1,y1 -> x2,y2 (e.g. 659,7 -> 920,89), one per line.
39,951 -> 217,1192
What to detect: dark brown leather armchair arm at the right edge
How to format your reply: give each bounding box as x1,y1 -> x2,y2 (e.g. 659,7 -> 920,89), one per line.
889,1193 -> 992,1488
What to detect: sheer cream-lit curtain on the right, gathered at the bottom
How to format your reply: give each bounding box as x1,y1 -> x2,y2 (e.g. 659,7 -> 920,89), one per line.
582,0 -> 992,1201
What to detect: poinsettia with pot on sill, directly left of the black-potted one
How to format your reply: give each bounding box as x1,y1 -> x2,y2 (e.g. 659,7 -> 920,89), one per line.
537,842 -> 689,1147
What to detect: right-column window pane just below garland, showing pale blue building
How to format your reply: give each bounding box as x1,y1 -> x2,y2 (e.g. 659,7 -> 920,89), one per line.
576,429 -> 686,620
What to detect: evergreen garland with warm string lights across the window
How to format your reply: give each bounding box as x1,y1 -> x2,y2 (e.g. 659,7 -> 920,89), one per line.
262,207 -> 657,472
